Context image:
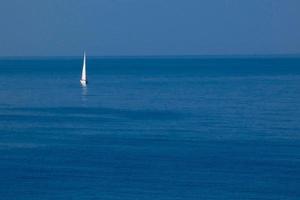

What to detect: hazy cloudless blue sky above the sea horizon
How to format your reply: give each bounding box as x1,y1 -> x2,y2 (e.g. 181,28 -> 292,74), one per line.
0,0 -> 300,56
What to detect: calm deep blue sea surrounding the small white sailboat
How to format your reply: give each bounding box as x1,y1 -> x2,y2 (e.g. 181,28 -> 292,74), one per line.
0,57 -> 300,200
